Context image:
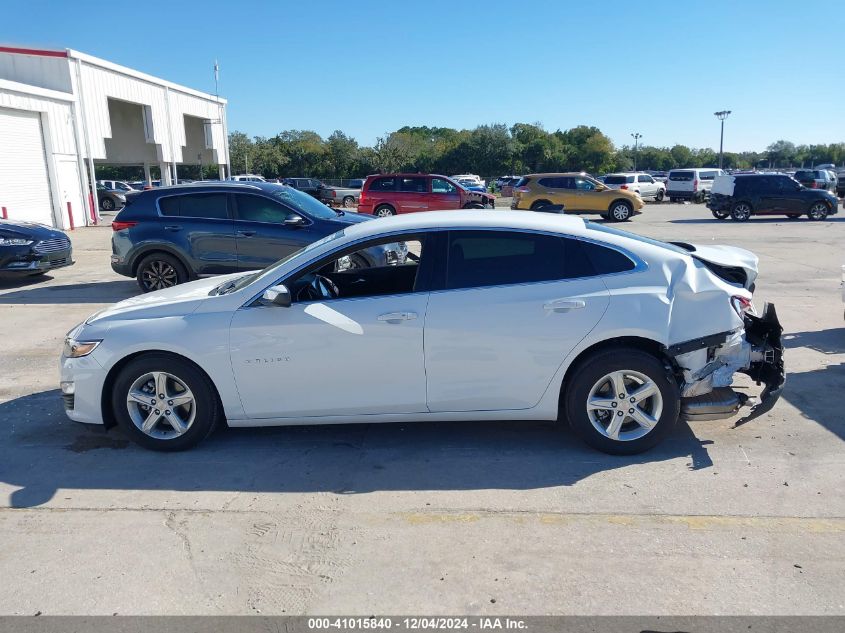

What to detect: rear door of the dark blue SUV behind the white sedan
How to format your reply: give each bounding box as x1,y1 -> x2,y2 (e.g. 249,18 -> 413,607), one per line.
158,191 -> 238,275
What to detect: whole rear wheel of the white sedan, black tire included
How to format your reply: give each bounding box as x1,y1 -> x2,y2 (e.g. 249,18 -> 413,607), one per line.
563,347 -> 681,455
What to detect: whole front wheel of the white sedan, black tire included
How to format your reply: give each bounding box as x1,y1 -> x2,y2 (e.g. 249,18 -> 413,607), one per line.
111,353 -> 223,451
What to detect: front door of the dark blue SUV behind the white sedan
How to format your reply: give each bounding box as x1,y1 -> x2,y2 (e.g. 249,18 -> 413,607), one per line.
232,193 -> 323,270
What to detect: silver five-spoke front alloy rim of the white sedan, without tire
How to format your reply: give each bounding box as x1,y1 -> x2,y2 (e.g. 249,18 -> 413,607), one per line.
126,371 -> 197,440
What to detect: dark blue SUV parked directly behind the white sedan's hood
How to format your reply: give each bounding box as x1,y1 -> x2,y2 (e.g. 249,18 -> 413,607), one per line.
111,182 -> 407,292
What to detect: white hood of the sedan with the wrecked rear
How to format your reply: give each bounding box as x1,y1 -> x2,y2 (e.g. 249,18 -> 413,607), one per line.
85,272 -> 241,324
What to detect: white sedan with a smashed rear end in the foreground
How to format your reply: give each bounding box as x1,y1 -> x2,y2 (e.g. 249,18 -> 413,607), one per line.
61,211 -> 784,454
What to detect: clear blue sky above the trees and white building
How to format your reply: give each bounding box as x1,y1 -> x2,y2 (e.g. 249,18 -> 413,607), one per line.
0,0 -> 845,151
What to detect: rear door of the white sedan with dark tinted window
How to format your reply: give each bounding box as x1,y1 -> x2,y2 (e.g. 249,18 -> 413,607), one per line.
425,230 -> 609,412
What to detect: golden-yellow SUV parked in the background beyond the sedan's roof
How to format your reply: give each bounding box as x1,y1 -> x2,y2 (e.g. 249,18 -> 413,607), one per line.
511,173 -> 645,222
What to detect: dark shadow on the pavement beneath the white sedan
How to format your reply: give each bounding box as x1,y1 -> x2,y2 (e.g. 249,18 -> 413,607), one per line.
0,390 -> 712,508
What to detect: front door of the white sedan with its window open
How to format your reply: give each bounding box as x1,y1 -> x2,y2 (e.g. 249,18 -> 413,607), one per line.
229,236 -> 431,420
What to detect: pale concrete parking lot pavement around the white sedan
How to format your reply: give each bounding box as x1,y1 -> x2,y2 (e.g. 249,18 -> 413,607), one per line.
0,201 -> 845,615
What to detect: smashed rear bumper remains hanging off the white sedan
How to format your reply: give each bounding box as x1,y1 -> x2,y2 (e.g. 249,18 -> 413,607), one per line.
667,303 -> 786,427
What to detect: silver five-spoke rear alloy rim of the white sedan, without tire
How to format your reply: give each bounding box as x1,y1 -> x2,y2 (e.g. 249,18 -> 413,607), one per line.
586,369 -> 663,442
